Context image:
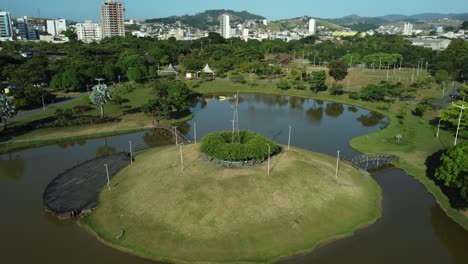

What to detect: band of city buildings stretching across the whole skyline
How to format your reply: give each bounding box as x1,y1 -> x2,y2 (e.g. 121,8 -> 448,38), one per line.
0,0 -> 467,50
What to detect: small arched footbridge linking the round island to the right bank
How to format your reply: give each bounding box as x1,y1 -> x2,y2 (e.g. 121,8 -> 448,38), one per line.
341,154 -> 400,170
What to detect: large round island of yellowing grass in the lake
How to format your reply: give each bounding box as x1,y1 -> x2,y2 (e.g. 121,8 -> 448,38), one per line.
80,145 -> 381,263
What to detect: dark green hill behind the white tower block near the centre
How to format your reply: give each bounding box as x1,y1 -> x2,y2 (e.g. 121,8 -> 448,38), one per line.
146,9 -> 265,30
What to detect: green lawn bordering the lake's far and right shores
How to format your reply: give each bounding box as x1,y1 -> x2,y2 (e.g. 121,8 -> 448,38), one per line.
193,80 -> 468,230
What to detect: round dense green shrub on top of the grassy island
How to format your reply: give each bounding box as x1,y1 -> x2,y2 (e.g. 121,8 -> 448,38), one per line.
200,131 -> 280,161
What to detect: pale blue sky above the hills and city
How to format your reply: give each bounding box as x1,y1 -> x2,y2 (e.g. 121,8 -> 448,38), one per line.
0,0 -> 468,22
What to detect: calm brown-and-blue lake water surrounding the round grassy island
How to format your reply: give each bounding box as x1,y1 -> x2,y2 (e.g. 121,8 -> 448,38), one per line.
0,95 -> 468,264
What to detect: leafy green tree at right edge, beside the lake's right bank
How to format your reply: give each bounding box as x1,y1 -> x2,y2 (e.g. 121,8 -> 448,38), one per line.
435,141 -> 468,201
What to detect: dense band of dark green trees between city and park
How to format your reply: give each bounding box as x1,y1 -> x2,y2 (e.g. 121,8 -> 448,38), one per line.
0,33 -> 468,108
